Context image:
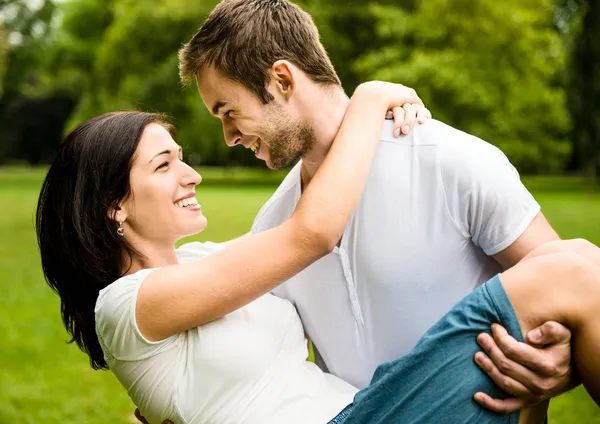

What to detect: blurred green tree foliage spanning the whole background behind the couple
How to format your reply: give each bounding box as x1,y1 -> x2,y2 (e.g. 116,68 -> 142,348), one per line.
0,0 -> 600,172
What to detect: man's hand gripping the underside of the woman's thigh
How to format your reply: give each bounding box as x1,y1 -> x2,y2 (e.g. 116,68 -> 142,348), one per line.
475,322 -> 577,413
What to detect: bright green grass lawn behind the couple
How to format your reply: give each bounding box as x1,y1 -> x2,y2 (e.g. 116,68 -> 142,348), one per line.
0,169 -> 600,424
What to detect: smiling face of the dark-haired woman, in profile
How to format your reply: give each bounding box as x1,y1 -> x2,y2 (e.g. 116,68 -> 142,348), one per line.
117,123 -> 207,243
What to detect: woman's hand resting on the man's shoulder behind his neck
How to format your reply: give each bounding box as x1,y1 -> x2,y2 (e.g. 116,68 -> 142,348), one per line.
356,81 -> 431,137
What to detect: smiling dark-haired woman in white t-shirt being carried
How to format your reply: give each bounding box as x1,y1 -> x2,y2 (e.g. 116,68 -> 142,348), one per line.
37,83 -> 600,424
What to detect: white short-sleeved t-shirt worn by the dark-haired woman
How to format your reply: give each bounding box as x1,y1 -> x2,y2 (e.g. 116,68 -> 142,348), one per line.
96,243 -> 356,424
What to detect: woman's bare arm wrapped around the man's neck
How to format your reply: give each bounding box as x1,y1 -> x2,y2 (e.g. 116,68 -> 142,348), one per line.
136,82 -> 421,340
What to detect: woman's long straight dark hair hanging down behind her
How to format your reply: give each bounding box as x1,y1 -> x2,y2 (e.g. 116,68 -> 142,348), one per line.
36,112 -> 168,369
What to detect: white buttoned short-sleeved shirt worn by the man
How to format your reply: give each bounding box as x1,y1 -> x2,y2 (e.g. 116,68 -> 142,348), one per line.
252,120 -> 540,388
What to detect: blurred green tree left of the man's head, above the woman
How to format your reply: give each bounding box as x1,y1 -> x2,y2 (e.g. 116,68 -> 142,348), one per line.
52,0 -> 243,165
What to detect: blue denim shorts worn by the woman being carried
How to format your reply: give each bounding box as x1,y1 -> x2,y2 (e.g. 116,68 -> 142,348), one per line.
330,276 -> 523,424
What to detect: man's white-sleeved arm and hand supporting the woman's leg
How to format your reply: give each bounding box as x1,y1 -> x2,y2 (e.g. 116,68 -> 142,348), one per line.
438,124 -> 571,412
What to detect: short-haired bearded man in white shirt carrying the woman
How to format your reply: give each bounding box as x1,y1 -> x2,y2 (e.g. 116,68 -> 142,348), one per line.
180,0 -> 572,418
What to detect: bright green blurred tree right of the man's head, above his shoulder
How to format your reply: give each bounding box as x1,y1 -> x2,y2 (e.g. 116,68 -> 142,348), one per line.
357,0 -> 570,172
